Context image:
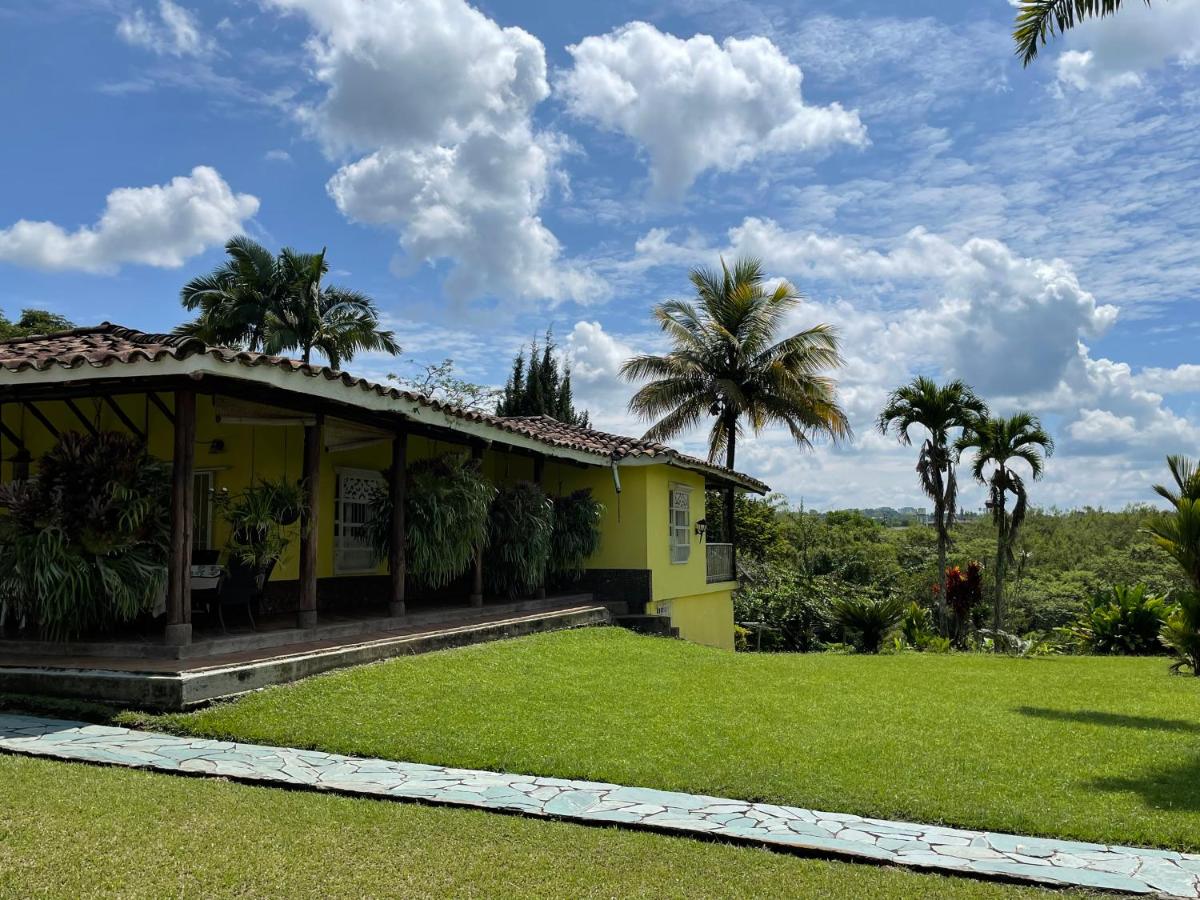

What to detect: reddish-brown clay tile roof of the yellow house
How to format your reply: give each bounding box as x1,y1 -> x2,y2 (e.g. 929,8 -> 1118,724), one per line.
0,322 -> 768,492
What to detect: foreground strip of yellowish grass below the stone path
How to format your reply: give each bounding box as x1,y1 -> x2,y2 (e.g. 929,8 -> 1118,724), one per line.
0,756 -> 1070,899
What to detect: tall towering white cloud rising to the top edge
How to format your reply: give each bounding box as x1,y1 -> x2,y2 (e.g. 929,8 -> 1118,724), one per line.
271,0 -> 602,300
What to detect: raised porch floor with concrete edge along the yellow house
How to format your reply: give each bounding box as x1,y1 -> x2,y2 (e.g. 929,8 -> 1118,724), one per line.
0,594 -> 612,709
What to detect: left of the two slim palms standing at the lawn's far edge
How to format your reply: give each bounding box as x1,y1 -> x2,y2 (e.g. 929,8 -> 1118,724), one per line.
877,376 -> 988,634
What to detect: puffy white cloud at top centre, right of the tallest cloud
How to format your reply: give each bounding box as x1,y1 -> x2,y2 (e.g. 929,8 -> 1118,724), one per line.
557,22 -> 866,197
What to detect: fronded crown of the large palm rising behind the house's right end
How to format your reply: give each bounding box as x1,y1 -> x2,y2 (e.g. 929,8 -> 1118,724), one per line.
620,258 -> 851,480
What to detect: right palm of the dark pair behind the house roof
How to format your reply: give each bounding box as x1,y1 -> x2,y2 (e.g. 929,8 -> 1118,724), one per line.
263,248 -> 400,368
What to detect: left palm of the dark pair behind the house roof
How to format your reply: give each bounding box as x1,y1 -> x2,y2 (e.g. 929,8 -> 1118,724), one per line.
175,235 -> 292,350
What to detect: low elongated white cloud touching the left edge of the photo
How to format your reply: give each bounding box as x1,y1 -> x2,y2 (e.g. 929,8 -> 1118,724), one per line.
0,166 -> 258,274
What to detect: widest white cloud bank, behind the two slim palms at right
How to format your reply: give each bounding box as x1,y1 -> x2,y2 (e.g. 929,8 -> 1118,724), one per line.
624,218 -> 1200,506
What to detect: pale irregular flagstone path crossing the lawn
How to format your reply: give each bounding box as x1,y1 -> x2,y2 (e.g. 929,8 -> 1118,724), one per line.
0,714 -> 1200,899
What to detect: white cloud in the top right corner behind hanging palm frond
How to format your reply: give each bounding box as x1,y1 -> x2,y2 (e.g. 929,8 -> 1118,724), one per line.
1055,0 -> 1200,92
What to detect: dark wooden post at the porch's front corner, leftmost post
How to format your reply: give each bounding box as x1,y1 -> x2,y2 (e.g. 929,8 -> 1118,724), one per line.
164,391 -> 196,647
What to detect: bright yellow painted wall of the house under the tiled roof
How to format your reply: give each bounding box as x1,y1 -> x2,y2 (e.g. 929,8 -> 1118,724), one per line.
0,394 -> 733,647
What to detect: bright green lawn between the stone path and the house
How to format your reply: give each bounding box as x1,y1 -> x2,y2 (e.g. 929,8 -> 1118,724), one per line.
131,629 -> 1200,850
